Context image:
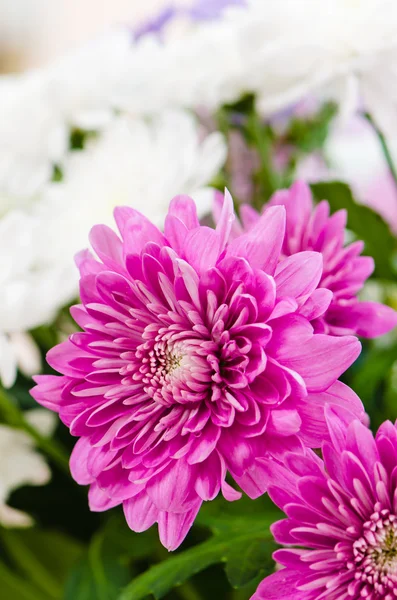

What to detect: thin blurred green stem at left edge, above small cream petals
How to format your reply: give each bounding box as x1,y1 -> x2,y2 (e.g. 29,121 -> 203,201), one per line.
0,388 -> 70,475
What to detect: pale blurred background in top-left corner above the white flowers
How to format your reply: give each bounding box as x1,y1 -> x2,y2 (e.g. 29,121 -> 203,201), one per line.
0,0 -> 187,73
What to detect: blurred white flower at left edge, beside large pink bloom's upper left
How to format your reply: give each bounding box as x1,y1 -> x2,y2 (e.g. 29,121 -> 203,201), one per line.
0,209 -> 69,387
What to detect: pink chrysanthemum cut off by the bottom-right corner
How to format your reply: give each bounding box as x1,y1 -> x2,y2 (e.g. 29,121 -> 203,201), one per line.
252,407 -> 397,600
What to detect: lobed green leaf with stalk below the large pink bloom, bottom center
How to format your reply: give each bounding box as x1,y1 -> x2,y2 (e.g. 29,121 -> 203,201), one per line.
118,498 -> 280,600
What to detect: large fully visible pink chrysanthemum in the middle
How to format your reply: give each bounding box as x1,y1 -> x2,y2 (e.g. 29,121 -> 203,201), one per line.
33,193 -> 363,549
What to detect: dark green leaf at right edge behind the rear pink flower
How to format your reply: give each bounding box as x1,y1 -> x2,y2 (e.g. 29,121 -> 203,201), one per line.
311,181 -> 396,279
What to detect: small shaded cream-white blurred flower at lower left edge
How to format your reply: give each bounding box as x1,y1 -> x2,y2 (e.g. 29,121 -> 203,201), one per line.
0,409 -> 56,527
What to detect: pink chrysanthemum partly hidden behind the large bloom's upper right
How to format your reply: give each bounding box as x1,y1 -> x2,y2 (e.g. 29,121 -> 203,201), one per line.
214,181 -> 397,338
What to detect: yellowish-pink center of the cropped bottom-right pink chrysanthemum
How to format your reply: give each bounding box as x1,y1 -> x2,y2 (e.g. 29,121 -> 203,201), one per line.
353,510 -> 397,600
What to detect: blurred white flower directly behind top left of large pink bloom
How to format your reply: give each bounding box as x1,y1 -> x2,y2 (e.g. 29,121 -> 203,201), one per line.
36,111 -> 226,272
